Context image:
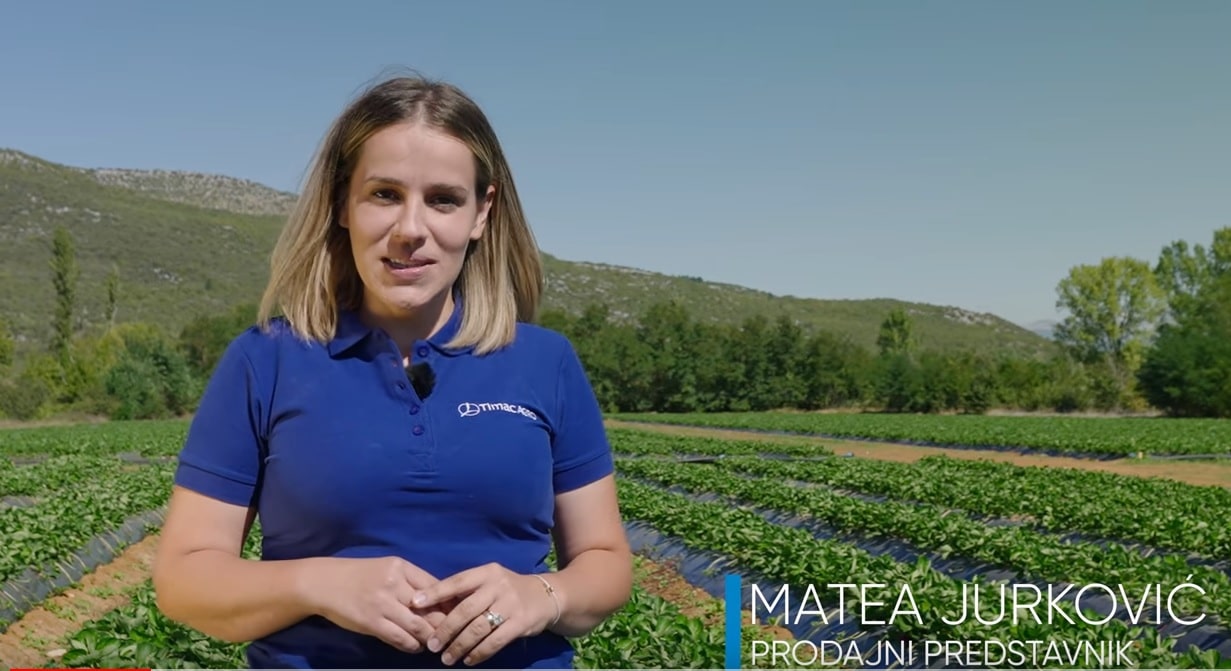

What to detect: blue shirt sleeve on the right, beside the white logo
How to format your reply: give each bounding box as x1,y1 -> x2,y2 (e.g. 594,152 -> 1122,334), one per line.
551,342 -> 614,494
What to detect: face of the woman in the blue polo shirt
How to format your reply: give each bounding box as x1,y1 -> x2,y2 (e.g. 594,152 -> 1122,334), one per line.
342,123 -> 495,325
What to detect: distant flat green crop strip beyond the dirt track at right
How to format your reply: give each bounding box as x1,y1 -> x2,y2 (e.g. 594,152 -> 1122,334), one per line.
611,412 -> 1231,456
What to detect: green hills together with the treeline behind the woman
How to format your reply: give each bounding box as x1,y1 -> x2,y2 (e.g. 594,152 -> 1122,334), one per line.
0,151 -> 1231,419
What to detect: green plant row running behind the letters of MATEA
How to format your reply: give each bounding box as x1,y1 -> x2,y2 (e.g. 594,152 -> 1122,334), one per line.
620,480 -> 1220,669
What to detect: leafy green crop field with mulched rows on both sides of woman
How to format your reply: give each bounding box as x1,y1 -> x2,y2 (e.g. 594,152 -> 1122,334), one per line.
0,415 -> 1231,669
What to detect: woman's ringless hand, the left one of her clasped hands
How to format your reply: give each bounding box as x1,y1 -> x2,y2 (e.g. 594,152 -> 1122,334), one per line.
307,556 -> 455,653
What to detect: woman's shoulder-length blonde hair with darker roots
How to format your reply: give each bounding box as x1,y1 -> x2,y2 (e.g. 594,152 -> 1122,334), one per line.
259,76 -> 543,353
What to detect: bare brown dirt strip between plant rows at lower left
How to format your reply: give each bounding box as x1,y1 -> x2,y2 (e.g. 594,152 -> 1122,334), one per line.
0,536 -> 158,671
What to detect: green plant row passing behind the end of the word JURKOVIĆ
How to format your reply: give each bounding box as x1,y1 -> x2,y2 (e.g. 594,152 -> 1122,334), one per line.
619,458 -> 1231,622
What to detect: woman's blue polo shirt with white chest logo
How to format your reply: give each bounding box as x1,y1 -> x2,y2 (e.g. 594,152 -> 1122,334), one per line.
175,302 -> 613,669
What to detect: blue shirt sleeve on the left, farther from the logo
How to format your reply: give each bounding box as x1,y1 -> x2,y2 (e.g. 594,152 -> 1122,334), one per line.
175,332 -> 267,506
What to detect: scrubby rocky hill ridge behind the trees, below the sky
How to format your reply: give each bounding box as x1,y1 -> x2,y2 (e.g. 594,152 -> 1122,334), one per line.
0,149 -> 1050,353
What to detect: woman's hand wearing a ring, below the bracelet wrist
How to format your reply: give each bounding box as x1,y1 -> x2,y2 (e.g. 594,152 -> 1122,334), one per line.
411,564 -> 556,665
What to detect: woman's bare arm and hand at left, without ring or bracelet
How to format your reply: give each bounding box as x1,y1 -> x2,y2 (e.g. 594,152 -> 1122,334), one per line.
154,486 -> 444,653
